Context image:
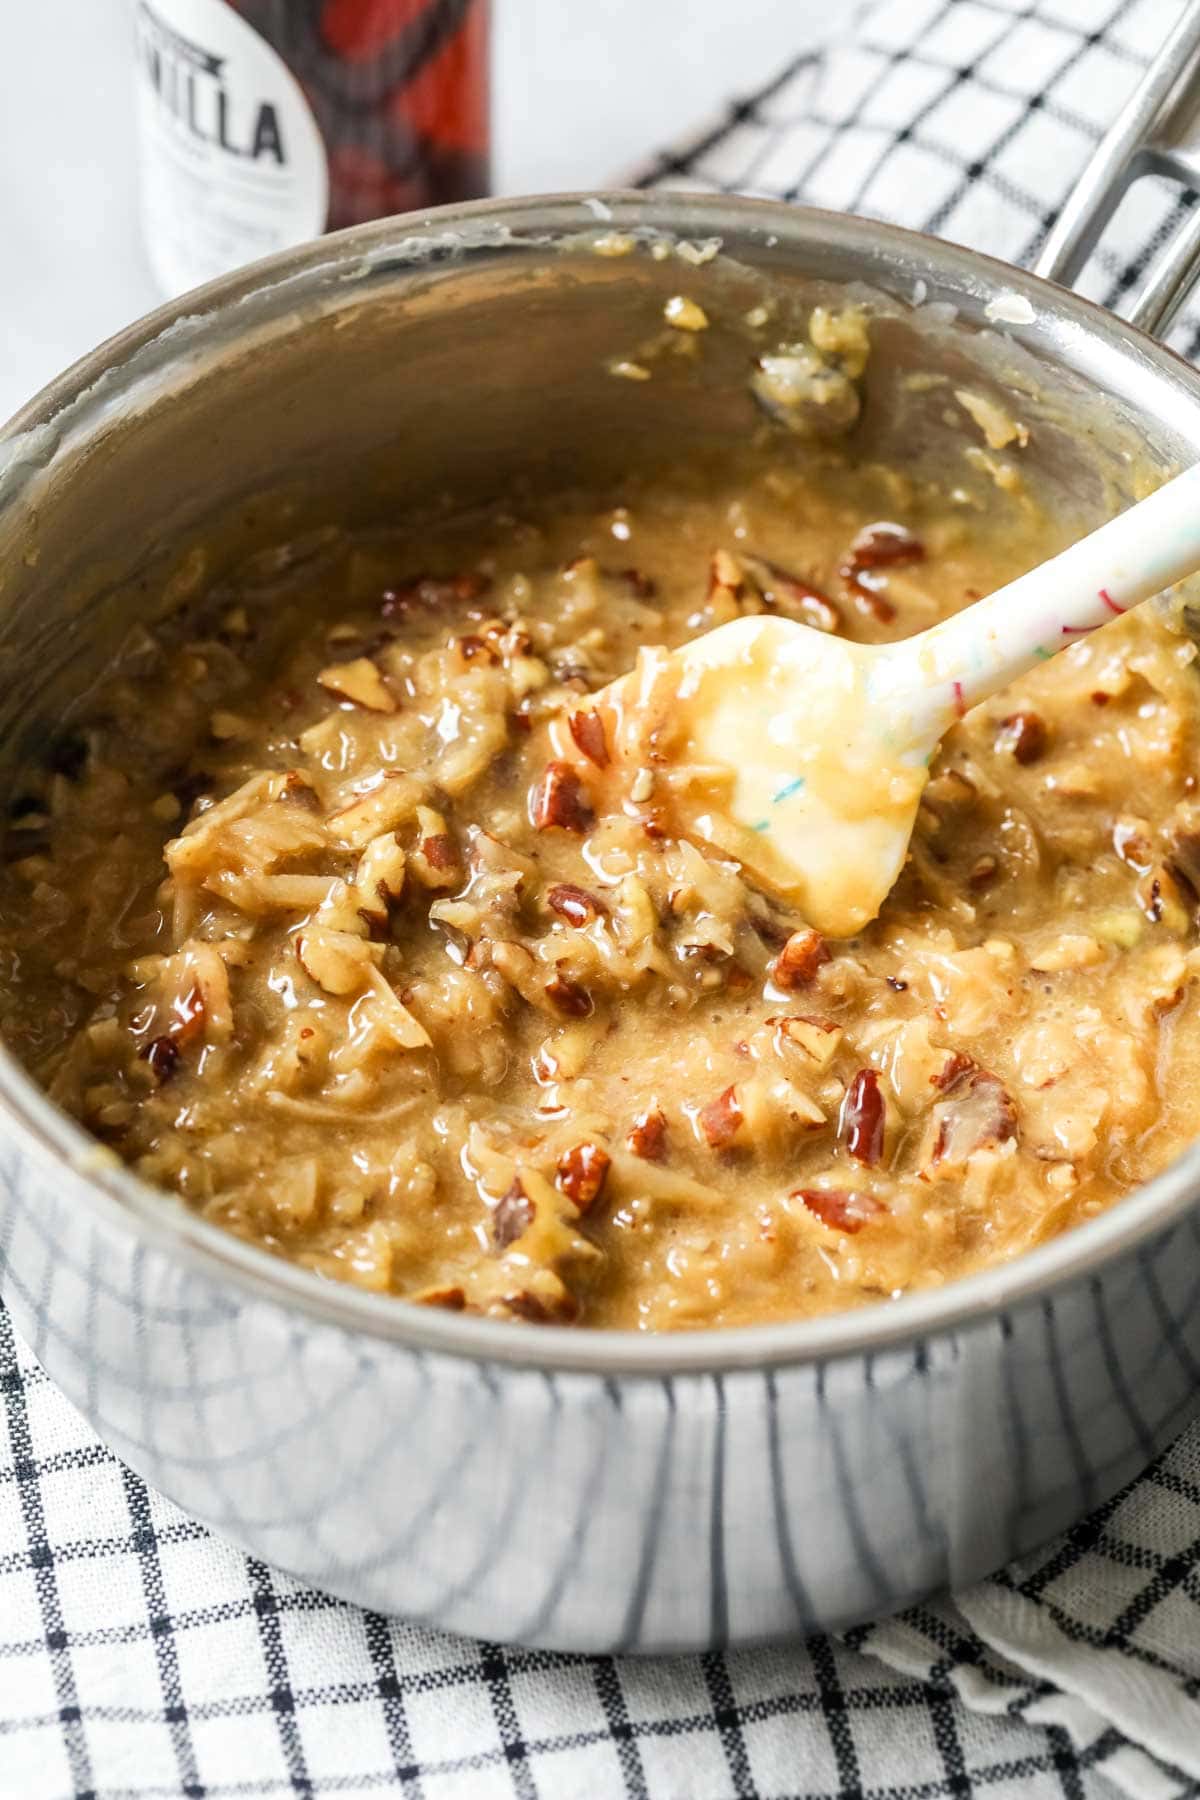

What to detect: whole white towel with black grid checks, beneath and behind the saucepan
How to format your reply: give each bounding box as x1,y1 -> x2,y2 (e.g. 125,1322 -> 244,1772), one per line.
0,0 -> 1200,1800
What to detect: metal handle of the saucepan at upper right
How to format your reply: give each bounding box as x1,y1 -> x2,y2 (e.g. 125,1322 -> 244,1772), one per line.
1033,0 -> 1200,337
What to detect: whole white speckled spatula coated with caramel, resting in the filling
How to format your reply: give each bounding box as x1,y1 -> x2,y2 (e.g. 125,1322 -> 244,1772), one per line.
590,464 -> 1200,938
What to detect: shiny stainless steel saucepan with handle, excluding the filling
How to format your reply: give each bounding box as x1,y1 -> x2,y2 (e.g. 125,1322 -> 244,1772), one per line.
0,31 -> 1200,1651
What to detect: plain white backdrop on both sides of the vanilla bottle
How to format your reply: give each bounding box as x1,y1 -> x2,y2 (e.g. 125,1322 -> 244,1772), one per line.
0,0 -> 820,419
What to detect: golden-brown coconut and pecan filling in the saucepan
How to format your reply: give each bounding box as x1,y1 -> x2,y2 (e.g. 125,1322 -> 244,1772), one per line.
0,450 -> 1200,1330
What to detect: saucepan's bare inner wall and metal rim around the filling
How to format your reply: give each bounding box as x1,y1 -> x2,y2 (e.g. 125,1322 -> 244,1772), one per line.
0,194 -> 1200,1368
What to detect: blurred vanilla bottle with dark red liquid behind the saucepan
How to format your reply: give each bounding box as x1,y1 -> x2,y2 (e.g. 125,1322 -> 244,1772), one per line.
135,0 -> 489,293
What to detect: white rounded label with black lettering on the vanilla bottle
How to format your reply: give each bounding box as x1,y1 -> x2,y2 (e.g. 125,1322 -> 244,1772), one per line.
137,0 -> 329,293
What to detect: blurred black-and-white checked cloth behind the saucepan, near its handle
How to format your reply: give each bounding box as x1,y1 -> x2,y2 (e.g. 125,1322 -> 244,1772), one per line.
633,0 -> 1200,358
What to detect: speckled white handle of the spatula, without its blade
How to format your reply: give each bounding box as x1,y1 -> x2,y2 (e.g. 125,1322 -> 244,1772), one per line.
871,464 -> 1200,752
